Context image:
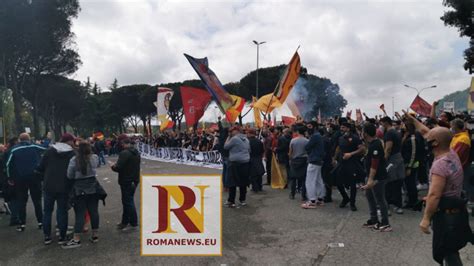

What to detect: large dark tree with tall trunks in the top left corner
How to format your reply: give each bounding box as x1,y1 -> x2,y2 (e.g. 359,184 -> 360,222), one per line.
0,0 -> 80,135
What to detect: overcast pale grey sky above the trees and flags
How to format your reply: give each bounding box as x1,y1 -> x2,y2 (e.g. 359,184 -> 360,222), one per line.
73,0 -> 470,118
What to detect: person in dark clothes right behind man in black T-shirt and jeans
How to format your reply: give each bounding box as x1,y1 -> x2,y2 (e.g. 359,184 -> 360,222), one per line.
380,116 -> 406,214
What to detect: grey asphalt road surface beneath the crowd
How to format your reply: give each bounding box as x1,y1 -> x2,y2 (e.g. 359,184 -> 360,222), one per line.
0,158 -> 474,265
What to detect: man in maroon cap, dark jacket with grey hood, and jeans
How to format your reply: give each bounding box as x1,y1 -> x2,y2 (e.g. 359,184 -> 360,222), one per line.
37,133 -> 75,245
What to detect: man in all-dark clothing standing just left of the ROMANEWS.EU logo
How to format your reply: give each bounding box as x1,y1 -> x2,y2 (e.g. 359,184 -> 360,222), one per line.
112,135 -> 140,230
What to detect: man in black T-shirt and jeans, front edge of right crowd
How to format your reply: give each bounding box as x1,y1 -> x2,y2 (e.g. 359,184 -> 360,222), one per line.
362,123 -> 392,232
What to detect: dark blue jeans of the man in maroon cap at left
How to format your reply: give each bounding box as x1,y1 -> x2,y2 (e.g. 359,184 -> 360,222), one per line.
43,192 -> 68,238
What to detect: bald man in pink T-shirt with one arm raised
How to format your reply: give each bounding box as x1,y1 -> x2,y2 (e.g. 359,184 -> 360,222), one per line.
405,113 -> 474,265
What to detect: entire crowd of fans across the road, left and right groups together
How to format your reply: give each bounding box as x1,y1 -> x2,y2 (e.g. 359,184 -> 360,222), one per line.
0,106 -> 474,265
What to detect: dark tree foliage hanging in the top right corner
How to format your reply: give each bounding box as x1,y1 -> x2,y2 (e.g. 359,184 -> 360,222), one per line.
441,0 -> 474,74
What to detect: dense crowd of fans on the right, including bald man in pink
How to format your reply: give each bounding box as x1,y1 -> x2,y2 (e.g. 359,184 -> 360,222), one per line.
216,108 -> 474,265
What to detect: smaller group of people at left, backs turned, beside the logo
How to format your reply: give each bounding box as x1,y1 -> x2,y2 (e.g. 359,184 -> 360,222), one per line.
0,133 -> 140,249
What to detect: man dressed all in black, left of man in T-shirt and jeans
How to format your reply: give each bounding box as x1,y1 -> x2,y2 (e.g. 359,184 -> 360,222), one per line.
333,122 -> 365,211
